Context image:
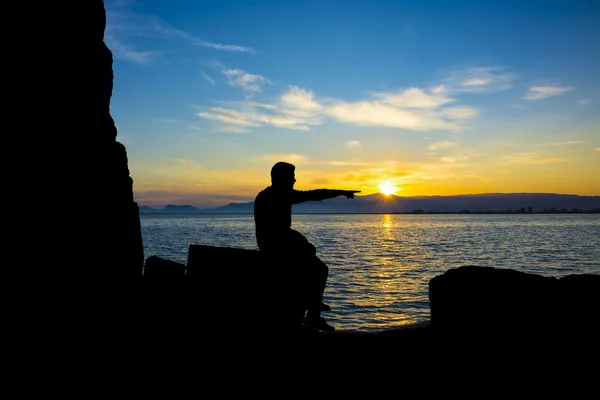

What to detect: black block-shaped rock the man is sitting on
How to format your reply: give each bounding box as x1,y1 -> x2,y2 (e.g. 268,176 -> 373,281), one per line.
186,245 -> 312,332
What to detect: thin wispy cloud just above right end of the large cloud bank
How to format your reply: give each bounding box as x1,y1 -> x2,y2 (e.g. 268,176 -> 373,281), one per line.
436,66 -> 517,93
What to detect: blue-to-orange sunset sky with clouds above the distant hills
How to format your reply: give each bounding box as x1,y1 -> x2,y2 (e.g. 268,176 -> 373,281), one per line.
105,0 -> 600,208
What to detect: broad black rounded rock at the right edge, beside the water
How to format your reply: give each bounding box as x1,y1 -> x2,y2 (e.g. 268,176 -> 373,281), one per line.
429,266 -> 600,341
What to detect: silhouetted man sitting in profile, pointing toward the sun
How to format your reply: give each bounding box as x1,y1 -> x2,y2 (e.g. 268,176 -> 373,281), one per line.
254,162 -> 360,331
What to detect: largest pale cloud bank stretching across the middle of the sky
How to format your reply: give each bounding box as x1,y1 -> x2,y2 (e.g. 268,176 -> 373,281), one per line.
198,68 -> 492,131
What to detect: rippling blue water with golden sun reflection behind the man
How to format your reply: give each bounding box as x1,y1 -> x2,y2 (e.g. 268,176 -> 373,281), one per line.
140,214 -> 600,331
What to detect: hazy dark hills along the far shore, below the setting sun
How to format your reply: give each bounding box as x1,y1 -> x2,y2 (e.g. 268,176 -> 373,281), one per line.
140,193 -> 600,214
